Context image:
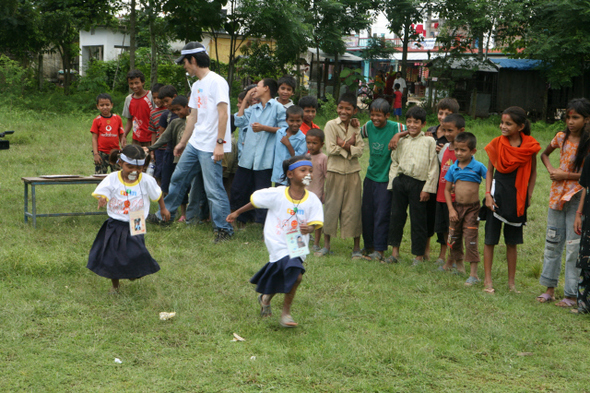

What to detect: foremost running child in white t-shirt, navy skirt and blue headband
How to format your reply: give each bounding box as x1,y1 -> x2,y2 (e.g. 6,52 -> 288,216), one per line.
227,156 -> 324,327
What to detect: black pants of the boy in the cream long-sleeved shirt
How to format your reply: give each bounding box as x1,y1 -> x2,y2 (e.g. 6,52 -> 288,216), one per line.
389,175 -> 428,256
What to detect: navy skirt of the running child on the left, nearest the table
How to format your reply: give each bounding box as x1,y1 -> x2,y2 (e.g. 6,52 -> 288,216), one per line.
86,218 -> 160,279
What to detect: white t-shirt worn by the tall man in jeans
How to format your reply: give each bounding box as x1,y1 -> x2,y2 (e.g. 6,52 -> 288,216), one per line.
188,71 -> 231,153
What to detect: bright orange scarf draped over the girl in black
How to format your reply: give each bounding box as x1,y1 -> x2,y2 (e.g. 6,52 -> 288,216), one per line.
485,132 -> 541,217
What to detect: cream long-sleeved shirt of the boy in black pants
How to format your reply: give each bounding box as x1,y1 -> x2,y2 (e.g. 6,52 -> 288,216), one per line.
387,132 -> 438,194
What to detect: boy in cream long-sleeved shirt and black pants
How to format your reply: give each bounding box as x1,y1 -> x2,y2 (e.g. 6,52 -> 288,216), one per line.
387,106 -> 438,266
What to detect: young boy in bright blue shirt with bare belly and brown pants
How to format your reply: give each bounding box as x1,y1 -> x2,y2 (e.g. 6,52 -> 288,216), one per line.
445,132 -> 487,286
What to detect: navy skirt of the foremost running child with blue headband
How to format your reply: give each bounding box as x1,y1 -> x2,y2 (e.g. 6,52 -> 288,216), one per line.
250,255 -> 305,295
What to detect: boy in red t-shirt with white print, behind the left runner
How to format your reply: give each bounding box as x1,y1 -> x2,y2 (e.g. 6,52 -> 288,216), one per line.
90,93 -> 126,175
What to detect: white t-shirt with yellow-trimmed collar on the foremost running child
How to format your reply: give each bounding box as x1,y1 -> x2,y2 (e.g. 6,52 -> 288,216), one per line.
250,186 -> 324,262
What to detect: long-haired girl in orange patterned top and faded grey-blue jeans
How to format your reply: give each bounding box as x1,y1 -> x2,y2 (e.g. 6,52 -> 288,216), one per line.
537,98 -> 590,307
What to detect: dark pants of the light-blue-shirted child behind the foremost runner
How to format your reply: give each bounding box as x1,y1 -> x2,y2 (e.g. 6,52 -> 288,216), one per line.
230,166 -> 272,224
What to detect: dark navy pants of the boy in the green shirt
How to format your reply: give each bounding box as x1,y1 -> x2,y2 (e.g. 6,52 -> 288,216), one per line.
361,177 -> 391,251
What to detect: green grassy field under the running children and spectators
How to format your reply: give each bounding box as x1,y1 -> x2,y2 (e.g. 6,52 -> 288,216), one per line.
0,108 -> 590,392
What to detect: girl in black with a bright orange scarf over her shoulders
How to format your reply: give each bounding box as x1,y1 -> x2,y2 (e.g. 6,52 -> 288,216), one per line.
484,106 -> 541,293
